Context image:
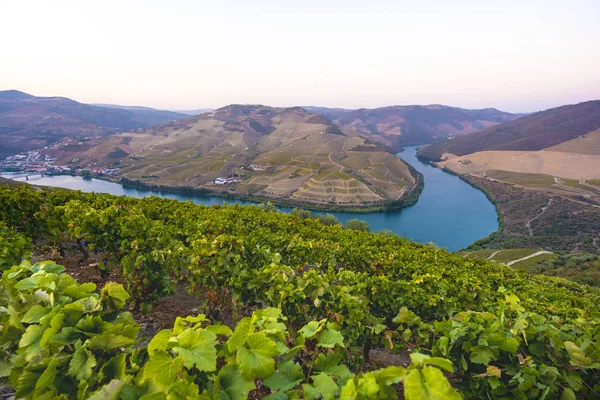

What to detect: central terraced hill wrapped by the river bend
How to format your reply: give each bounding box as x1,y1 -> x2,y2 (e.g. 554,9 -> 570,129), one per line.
65,105 -> 417,211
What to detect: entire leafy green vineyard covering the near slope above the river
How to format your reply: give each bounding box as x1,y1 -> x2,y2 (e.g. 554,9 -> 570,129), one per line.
0,187 -> 600,399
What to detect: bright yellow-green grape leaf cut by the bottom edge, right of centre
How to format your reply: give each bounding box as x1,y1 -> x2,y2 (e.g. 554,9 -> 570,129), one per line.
404,366 -> 462,400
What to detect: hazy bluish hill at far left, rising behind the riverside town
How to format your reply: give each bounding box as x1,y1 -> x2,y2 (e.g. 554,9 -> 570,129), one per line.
0,90 -> 185,158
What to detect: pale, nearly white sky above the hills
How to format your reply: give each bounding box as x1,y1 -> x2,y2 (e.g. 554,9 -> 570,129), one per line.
0,0 -> 600,112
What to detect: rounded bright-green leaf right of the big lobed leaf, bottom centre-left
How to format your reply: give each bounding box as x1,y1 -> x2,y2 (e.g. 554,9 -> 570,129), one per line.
235,333 -> 279,379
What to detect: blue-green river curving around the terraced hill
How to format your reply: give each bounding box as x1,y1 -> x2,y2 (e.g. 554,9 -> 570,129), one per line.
5,147 -> 498,251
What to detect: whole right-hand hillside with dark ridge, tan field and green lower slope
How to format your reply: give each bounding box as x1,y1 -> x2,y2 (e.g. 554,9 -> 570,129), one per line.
419,101 -> 600,252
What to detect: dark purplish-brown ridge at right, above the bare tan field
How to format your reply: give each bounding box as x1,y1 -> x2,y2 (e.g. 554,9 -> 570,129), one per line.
420,100 -> 600,161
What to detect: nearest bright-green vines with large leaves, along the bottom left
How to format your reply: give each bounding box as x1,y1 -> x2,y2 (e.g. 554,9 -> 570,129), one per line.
0,262 -> 460,400
